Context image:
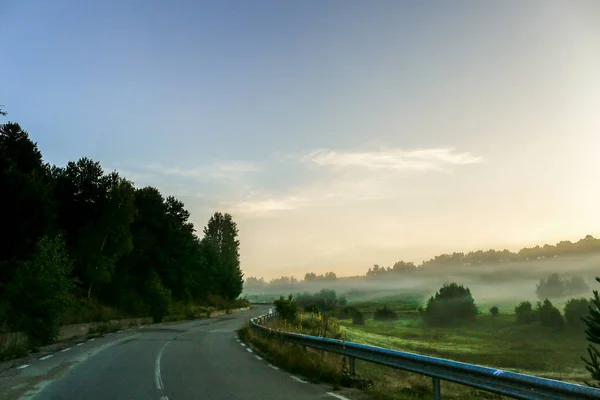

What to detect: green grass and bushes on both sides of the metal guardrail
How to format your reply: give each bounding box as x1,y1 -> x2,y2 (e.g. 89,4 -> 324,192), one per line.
242,283 -> 600,399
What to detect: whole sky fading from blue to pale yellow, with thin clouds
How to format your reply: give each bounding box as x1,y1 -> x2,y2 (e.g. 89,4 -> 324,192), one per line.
0,0 -> 600,279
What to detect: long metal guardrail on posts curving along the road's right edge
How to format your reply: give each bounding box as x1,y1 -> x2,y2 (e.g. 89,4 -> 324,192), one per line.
250,313 -> 600,400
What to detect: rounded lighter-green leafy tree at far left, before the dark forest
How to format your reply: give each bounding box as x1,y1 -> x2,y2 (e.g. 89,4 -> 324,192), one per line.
3,236 -> 73,347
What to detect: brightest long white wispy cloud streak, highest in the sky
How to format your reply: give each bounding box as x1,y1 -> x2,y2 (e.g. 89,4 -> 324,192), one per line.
300,148 -> 482,171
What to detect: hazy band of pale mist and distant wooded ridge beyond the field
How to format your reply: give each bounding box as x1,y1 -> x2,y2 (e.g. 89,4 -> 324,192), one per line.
244,236 -> 600,309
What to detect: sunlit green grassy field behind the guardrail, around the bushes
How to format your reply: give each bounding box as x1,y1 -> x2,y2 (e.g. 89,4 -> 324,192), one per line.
340,297 -> 589,383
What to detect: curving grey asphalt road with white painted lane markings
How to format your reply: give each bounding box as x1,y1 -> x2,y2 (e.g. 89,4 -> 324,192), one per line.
0,306 -> 356,400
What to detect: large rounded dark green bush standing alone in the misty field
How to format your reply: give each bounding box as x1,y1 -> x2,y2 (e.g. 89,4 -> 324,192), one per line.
423,283 -> 477,326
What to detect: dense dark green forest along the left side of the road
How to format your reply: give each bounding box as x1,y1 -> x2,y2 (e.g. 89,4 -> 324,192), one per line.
0,111 -> 243,342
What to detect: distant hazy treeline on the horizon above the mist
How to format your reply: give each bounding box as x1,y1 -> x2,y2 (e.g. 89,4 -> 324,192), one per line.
246,235 -> 600,289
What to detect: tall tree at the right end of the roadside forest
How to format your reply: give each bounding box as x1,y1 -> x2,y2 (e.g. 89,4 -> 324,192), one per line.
204,212 -> 244,300
